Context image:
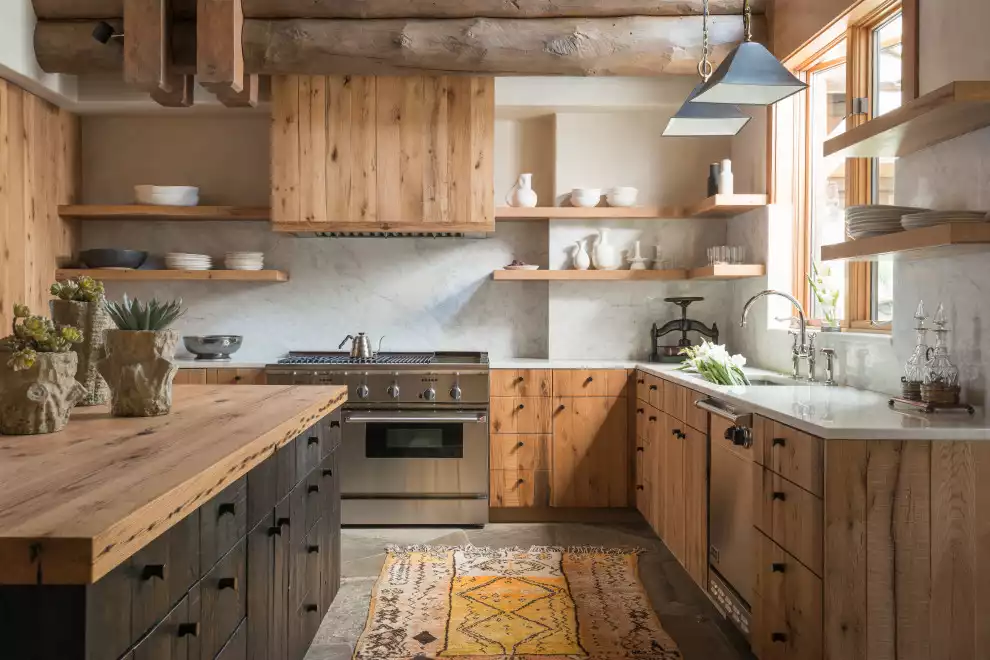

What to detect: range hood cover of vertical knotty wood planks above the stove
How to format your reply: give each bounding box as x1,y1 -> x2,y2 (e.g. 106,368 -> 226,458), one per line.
272,76 -> 495,232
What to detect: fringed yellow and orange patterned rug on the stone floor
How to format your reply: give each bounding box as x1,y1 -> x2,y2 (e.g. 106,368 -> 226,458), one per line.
354,546 -> 681,660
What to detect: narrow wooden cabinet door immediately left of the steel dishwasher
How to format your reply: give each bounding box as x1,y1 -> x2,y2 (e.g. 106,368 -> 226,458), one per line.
682,427 -> 708,590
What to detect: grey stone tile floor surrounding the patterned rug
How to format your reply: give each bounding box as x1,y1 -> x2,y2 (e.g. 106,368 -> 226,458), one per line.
306,523 -> 752,660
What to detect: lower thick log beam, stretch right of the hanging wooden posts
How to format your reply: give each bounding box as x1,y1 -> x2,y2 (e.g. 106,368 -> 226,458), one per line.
244,16 -> 766,76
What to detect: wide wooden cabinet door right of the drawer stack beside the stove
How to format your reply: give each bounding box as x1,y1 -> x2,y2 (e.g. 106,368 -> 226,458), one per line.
552,397 -> 629,507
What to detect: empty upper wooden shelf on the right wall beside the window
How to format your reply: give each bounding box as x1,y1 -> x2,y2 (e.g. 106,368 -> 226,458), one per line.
825,81 -> 990,158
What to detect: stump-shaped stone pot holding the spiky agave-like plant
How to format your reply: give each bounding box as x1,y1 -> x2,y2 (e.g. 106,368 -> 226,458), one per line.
98,329 -> 179,417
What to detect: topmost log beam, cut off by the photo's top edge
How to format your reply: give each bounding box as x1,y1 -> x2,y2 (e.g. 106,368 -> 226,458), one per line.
32,0 -> 766,20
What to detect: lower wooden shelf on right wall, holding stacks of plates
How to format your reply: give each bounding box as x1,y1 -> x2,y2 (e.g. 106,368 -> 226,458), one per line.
821,222 -> 990,261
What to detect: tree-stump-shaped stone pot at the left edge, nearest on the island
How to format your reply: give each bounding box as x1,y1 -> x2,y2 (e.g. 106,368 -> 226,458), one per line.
0,352 -> 86,435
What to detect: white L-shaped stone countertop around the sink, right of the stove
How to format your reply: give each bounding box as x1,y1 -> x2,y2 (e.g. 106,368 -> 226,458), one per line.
491,359 -> 990,440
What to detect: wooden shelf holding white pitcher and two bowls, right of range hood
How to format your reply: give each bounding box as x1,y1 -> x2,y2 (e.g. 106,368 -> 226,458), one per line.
495,195 -> 767,222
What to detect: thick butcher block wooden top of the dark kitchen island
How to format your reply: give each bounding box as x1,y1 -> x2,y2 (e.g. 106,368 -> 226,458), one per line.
0,385 -> 347,584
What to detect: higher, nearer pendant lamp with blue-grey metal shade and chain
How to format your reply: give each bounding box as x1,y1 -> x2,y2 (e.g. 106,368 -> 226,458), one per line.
695,0 -> 808,106
